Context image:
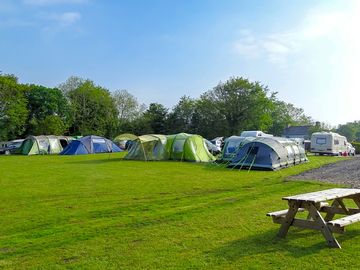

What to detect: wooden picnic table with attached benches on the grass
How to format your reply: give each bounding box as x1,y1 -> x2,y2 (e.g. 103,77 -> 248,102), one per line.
267,188 -> 360,248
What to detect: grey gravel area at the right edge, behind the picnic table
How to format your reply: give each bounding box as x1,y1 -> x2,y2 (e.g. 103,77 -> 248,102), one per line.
289,156 -> 360,188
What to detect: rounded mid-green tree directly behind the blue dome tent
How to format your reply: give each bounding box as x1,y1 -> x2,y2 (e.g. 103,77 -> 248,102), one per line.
68,80 -> 117,137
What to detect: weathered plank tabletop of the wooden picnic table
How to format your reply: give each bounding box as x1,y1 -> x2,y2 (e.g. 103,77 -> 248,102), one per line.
283,188 -> 360,203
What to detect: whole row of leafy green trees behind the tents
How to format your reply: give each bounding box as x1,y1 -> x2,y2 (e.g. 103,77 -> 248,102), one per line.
0,74 -> 313,140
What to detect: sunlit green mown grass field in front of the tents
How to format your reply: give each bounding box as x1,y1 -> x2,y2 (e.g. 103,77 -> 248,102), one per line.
0,154 -> 360,269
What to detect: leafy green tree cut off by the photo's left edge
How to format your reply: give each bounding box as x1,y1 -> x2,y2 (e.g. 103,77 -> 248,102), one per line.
0,75 -> 28,140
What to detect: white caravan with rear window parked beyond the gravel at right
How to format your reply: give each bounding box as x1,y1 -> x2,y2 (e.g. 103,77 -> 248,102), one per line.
310,132 -> 348,156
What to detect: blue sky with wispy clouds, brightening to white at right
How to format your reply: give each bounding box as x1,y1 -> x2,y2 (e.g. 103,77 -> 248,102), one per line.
0,0 -> 360,125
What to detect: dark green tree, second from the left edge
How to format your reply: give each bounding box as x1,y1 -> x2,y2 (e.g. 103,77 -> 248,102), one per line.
25,84 -> 71,135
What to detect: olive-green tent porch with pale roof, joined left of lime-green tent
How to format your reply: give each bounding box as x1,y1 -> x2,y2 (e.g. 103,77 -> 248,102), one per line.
124,134 -> 168,161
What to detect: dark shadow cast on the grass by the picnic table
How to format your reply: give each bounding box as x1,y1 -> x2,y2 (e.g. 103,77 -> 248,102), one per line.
209,229 -> 360,261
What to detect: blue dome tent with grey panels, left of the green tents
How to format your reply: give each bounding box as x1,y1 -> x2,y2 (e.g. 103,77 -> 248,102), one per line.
60,135 -> 122,155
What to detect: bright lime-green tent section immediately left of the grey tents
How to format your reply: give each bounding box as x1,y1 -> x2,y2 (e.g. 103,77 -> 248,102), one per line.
166,133 -> 215,162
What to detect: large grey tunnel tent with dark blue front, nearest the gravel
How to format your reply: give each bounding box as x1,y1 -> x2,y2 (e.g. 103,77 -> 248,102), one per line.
228,137 -> 308,170
